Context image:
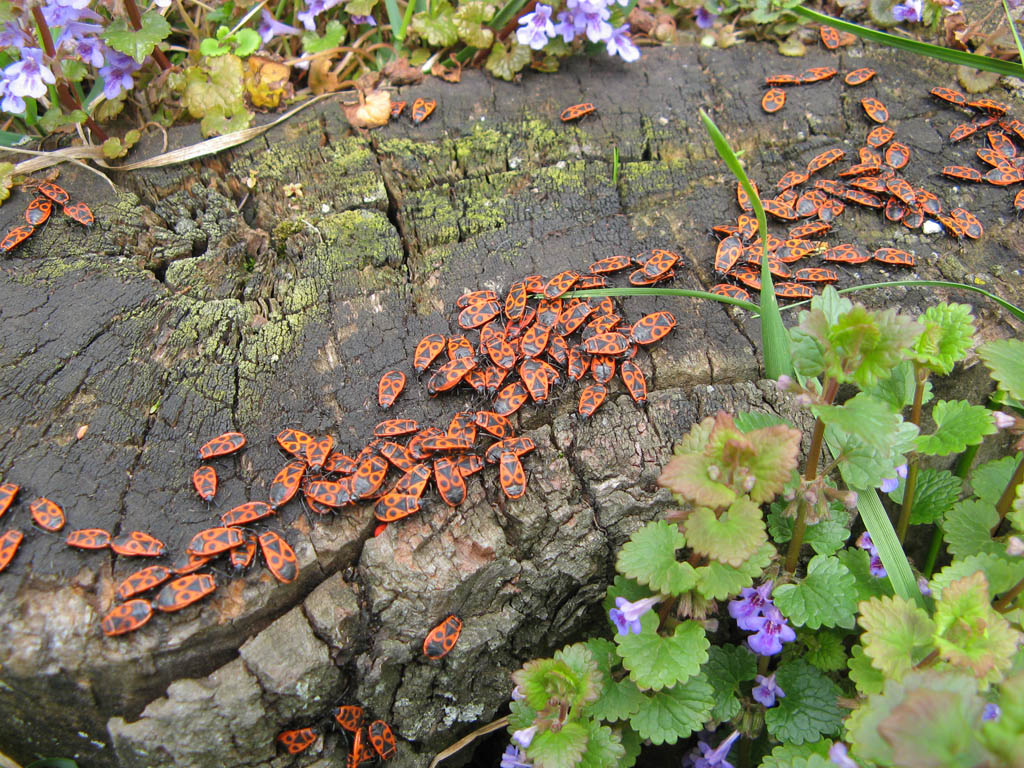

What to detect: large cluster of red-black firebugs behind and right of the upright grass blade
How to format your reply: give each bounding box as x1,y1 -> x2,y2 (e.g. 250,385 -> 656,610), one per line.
712,66 -> 987,300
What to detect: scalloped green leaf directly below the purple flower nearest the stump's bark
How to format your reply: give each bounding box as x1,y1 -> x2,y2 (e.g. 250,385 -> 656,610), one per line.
615,612 -> 711,692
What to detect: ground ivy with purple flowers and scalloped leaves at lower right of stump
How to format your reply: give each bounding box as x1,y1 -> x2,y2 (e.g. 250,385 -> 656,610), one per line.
501,289 -> 1024,768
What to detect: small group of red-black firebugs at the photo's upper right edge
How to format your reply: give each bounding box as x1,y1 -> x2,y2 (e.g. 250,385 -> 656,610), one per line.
929,87 -> 1024,215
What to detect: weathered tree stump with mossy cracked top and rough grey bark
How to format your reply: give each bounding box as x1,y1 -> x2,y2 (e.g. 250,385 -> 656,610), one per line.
0,45 -> 1022,768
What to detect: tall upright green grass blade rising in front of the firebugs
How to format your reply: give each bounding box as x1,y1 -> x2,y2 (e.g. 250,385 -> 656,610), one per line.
699,110 -> 794,379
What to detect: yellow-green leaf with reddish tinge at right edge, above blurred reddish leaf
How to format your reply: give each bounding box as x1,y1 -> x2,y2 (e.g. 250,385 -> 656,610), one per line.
935,572 -> 1021,683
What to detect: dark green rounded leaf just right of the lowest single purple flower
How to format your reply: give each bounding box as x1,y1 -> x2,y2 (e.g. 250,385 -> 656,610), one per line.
765,658 -> 843,744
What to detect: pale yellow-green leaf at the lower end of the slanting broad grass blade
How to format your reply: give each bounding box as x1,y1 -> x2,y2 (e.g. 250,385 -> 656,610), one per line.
858,597 -> 935,680
